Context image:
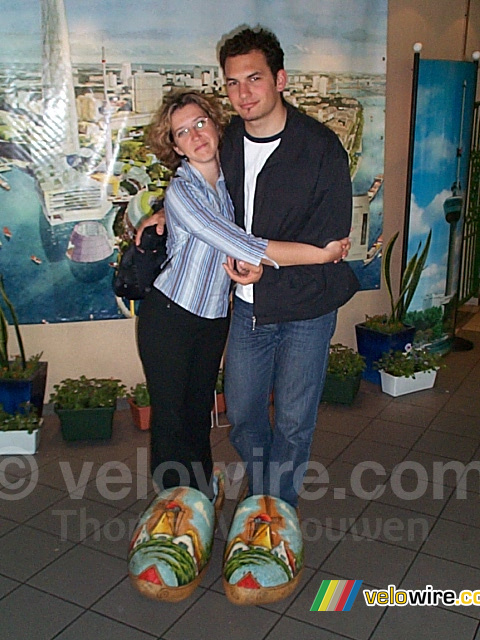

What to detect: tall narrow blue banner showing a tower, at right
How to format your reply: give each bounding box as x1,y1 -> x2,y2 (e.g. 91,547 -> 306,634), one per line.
406,60 -> 478,352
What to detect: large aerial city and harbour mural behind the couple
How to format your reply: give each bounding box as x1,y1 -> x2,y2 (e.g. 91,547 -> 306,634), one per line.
0,0 -> 387,323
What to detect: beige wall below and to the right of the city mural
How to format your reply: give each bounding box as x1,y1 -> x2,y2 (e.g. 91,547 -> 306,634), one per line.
7,0 -> 480,398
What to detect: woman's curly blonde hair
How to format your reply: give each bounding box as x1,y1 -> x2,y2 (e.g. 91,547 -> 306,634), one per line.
147,90 -> 229,171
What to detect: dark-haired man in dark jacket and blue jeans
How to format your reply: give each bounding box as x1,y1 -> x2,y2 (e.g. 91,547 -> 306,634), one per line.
220,29 -> 358,507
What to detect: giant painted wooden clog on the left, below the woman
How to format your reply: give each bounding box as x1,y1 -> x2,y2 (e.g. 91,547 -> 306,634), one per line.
128,487 -> 215,602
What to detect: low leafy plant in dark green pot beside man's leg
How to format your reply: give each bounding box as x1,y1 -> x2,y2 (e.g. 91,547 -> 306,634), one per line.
322,344 -> 365,405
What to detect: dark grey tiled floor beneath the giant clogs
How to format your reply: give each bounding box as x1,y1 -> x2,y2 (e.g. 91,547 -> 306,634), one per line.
0,328 -> 480,640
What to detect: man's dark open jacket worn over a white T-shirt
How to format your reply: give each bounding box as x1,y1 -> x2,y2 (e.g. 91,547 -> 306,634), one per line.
221,103 -> 359,324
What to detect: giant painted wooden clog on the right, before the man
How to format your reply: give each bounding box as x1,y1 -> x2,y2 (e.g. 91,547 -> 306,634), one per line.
223,495 -> 303,604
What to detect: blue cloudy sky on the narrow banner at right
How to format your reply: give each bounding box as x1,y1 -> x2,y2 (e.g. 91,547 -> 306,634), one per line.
408,60 -> 475,310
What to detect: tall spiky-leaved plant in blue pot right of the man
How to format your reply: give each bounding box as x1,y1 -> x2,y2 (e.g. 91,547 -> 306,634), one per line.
355,231 -> 432,384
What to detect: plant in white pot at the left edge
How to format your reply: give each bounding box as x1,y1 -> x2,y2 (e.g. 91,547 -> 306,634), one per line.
0,403 -> 42,456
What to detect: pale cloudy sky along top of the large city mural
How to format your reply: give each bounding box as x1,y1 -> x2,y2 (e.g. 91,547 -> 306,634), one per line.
0,0 -> 387,73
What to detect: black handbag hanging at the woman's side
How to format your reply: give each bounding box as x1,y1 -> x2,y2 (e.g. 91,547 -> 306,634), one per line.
112,226 -> 167,300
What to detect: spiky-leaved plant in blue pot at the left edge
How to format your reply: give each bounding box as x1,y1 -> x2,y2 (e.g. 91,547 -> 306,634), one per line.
0,275 -> 47,418
